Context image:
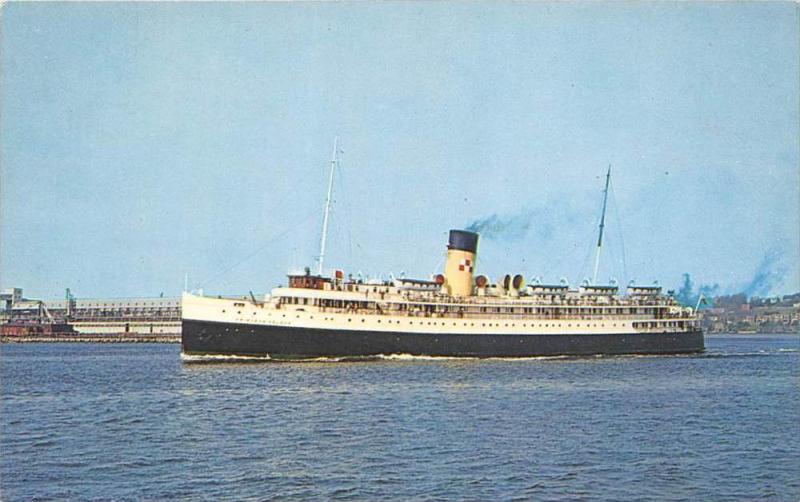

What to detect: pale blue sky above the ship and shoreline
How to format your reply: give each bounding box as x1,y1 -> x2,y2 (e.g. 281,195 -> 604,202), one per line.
0,1 -> 800,298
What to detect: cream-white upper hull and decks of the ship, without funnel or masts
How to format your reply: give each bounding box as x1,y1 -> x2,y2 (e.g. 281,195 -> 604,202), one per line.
182,275 -> 696,334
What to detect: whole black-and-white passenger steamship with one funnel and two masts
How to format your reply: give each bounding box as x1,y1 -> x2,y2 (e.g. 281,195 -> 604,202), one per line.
181,147 -> 704,360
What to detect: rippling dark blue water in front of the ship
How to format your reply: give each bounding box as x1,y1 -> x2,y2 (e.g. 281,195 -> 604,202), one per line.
0,335 -> 800,501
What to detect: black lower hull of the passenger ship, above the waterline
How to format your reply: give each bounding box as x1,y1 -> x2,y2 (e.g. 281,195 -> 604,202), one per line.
181,320 -> 705,359
